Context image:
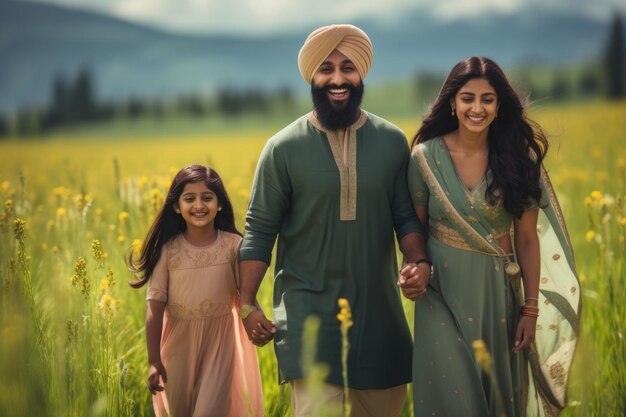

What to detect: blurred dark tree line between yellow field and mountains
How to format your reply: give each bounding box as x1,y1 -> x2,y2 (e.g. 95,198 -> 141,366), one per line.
0,14 -> 626,137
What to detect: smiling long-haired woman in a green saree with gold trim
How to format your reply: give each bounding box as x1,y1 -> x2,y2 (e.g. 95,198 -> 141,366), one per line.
403,57 -> 580,417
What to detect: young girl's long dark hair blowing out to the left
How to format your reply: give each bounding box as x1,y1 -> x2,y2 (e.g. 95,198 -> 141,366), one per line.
126,165 -> 241,288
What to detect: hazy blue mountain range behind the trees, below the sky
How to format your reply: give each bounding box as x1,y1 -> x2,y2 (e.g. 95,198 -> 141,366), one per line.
0,0 -> 609,112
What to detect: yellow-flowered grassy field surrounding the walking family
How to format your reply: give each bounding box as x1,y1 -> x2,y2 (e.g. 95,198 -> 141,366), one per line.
0,102 -> 626,417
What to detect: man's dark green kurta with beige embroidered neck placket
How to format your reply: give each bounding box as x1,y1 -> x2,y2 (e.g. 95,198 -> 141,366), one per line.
240,112 -> 421,389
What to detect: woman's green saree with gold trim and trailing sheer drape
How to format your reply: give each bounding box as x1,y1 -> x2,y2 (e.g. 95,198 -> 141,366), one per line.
408,138 -> 580,417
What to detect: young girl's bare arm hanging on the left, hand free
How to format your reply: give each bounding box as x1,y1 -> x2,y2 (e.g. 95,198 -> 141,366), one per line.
146,300 -> 167,395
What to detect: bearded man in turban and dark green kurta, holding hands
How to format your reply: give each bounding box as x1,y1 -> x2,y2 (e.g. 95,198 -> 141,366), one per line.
239,25 -> 430,417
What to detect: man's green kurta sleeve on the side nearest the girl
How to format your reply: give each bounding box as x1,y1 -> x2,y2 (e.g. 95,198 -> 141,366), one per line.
239,140 -> 291,265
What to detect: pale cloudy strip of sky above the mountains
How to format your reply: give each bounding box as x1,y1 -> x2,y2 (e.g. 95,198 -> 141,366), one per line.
19,0 -> 626,35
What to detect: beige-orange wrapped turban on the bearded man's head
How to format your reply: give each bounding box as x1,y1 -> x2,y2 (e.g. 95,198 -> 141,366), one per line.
298,25 -> 374,84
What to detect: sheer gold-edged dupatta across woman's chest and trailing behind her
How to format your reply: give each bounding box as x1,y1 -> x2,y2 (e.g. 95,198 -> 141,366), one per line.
413,143 -> 581,416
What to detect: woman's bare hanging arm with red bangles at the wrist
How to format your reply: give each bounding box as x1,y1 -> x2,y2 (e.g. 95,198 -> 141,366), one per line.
513,209 -> 541,352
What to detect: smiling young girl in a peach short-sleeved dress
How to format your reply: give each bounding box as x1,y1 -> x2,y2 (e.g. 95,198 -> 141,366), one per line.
128,165 -> 263,417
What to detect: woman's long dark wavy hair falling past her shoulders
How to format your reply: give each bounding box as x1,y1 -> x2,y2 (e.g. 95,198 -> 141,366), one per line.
411,56 -> 548,218
